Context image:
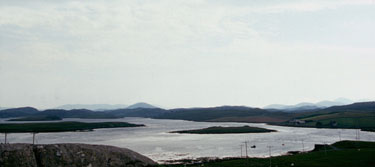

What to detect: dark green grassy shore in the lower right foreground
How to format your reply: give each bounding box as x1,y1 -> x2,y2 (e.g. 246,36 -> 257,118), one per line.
160,141 -> 375,167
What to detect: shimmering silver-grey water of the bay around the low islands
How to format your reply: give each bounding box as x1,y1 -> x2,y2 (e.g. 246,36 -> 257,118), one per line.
0,118 -> 375,162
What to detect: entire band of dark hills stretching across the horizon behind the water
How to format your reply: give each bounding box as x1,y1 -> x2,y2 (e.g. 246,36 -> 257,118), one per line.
0,102 -> 375,123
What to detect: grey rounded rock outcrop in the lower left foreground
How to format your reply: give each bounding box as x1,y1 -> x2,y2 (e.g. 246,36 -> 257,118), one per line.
0,144 -> 157,167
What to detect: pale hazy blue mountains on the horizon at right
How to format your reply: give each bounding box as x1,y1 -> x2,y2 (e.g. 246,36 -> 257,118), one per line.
263,98 -> 354,112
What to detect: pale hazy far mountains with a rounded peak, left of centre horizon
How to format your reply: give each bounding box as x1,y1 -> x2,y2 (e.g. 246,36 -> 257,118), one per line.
55,102 -> 157,111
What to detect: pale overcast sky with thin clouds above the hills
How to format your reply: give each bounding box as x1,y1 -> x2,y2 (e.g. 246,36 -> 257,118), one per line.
0,0 -> 375,108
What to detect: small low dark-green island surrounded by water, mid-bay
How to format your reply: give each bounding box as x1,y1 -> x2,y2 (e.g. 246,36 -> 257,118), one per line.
170,126 -> 276,134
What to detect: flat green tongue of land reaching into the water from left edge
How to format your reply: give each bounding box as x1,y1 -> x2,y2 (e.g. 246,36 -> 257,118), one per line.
0,122 -> 144,133
